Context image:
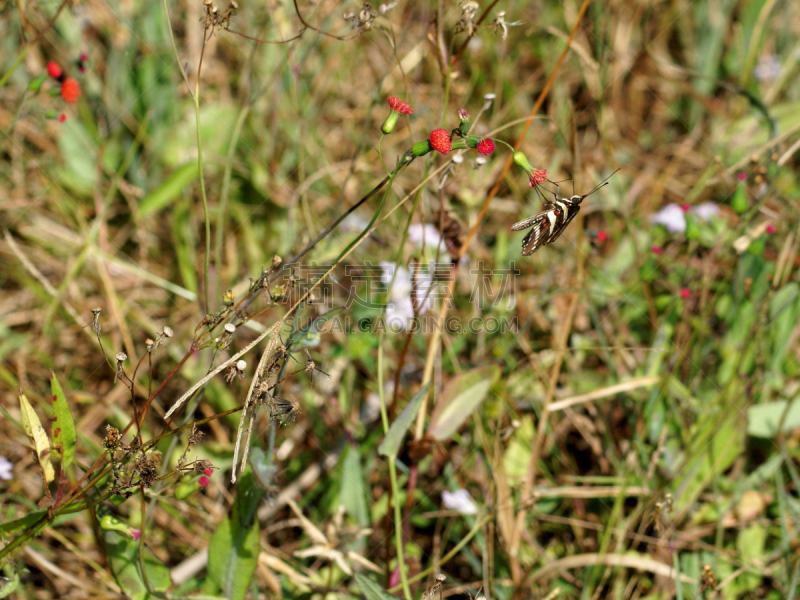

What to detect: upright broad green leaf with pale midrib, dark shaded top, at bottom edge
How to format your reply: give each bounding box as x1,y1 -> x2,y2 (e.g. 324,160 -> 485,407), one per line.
206,469 -> 264,600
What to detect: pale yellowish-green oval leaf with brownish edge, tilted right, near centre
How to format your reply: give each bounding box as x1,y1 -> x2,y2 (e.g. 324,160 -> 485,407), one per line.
428,365 -> 500,442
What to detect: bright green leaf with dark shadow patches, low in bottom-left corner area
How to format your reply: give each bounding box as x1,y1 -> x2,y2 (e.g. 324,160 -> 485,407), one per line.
98,515 -> 172,600
